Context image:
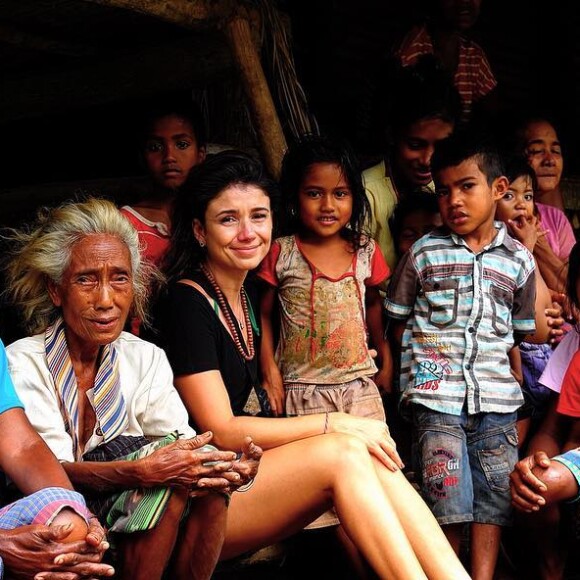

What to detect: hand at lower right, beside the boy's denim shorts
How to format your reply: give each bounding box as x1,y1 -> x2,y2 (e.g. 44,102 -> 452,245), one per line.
510,451 -> 550,513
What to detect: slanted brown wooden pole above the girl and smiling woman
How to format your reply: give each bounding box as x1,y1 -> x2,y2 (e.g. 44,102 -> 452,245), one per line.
225,14 -> 286,178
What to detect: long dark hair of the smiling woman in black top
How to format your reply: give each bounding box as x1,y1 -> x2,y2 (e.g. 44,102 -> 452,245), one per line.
163,150 -> 279,281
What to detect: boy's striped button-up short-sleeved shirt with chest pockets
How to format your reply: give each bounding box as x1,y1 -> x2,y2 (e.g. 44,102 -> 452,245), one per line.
385,222 -> 536,415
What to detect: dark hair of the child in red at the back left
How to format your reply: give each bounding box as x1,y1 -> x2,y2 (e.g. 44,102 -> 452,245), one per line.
137,97 -> 207,148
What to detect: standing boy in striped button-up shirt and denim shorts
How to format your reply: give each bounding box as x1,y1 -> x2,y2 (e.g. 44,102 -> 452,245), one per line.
386,133 -> 548,580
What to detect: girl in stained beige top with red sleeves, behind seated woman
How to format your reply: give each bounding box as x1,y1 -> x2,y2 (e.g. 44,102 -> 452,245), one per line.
258,137 -> 392,421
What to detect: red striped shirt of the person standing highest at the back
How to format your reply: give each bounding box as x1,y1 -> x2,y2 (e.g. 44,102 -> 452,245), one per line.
396,25 -> 497,122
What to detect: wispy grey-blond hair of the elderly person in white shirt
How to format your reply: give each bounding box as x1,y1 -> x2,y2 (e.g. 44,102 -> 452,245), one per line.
6,198 -> 162,333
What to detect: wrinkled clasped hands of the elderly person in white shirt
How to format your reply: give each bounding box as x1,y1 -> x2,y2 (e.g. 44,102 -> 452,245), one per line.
139,431 -> 247,495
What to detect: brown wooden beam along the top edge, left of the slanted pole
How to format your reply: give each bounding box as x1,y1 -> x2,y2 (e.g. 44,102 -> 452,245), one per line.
85,0 -> 236,28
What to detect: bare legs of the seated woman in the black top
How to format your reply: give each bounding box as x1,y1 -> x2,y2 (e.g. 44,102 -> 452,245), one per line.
222,434 -> 468,580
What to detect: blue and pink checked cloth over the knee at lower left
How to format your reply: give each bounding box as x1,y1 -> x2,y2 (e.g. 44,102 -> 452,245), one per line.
0,487 -> 89,579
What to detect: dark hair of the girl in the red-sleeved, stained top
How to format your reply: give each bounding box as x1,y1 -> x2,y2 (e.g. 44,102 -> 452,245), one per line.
280,135 -> 370,250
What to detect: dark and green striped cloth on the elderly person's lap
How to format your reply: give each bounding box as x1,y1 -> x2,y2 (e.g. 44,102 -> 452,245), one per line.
83,431 -> 179,534
